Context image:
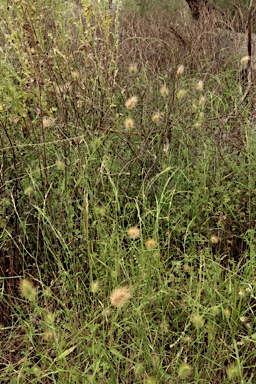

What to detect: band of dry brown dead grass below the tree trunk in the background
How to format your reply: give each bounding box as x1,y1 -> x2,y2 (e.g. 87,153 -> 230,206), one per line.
119,3 -> 256,74
